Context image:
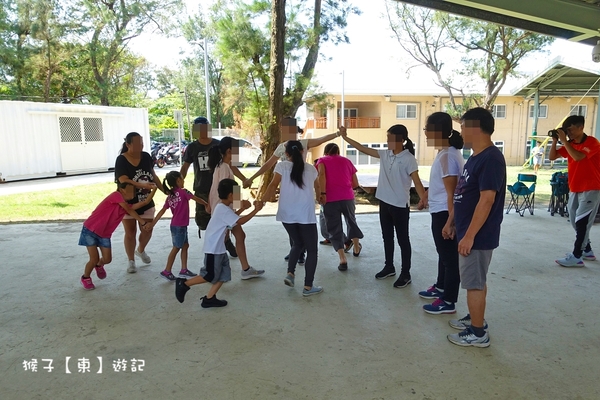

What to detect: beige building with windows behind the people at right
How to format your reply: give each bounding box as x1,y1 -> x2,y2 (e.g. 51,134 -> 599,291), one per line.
305,92 -> 598,166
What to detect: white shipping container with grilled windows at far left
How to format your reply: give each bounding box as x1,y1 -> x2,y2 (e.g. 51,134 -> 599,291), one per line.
0,100 -> 150,181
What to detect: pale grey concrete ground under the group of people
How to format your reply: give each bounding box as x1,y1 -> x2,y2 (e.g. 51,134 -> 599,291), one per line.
0,205 -> 600,399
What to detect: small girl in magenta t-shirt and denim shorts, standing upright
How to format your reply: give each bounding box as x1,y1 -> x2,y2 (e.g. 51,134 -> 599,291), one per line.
152,171 -> 210,281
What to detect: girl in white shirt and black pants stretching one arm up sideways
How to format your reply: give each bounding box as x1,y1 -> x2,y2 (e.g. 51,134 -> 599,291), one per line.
340,125 -> 426,288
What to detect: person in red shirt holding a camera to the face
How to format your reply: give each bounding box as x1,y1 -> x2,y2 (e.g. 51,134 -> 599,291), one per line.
549,115 -> 600,267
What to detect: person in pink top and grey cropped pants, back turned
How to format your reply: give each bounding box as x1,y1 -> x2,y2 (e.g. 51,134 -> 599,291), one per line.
317,143 -> 363,271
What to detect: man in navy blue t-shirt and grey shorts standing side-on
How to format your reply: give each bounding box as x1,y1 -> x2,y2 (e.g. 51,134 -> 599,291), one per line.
445,108 -> 506,347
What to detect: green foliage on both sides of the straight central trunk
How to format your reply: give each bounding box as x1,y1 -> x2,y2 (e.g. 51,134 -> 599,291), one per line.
207,0 -> 359,138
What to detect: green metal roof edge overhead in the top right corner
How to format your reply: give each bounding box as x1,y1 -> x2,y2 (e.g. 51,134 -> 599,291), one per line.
396,0 -> 600,46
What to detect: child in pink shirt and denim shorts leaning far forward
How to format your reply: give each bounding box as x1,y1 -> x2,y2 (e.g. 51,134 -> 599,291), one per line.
79,182 -> 156,290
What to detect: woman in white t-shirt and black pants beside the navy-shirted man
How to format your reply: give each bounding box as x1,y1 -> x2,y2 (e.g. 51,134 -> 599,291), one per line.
419,112 -> 465,314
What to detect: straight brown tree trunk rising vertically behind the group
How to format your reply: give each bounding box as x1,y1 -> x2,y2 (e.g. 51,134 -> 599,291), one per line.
258,0 -> 286,200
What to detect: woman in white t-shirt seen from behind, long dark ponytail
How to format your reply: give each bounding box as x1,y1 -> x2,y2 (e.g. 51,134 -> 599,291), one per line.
263,140 -> 323,296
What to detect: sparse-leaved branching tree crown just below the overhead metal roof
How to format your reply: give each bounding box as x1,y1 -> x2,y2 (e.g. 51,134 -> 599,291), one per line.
386,0 -> 554,116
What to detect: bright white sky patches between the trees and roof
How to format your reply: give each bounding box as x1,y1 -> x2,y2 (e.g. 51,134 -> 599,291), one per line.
132,0 -> 600,94
